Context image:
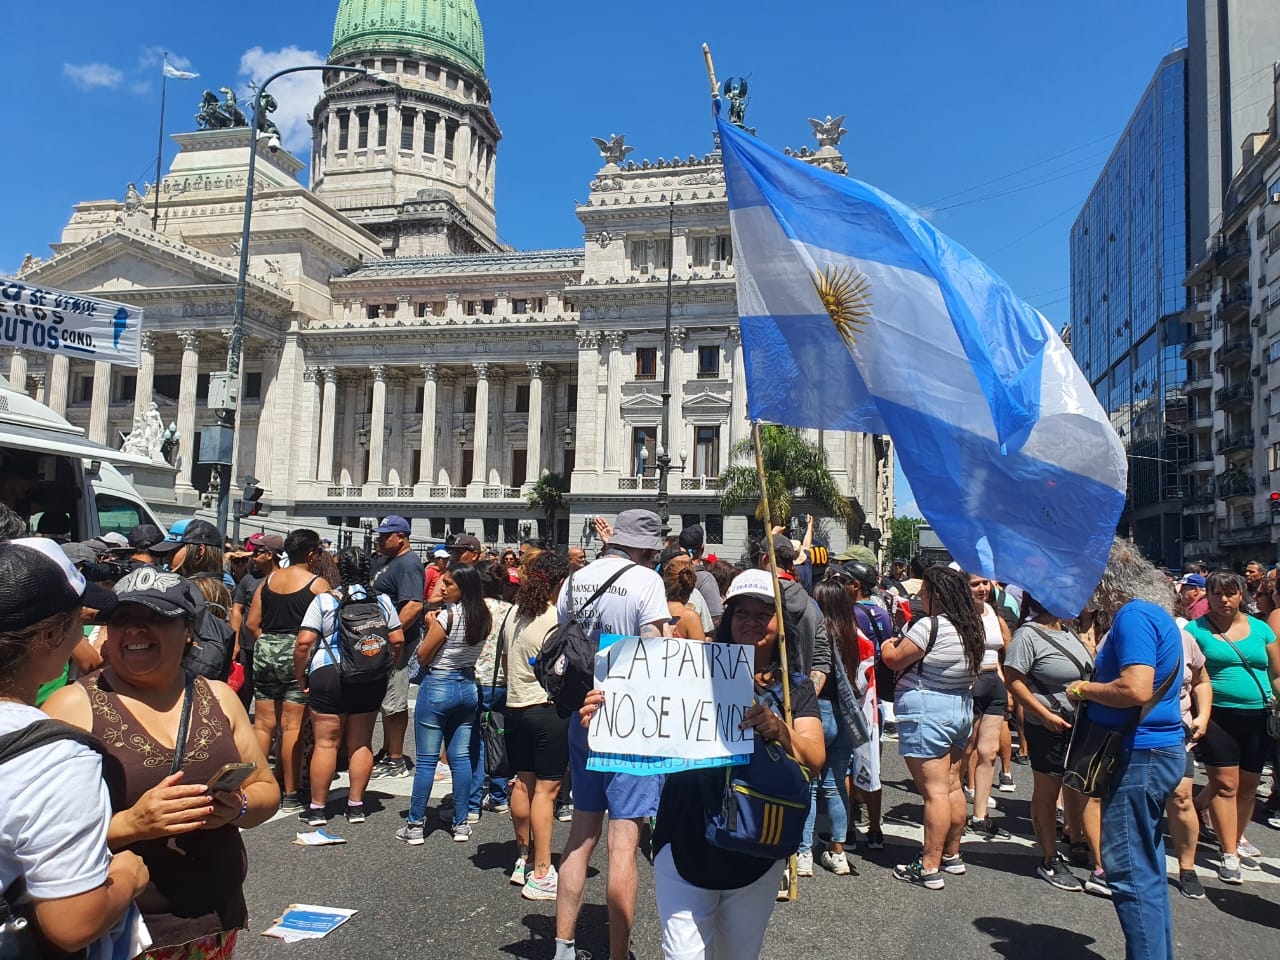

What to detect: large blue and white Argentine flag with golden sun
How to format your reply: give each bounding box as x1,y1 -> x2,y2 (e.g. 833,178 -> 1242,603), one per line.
717,106 -> 1126,617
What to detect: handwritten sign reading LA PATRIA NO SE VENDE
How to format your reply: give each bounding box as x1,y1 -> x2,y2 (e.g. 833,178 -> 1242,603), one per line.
588,636 -> 755,760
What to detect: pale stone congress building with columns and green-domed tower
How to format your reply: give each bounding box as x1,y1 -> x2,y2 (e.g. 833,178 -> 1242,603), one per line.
8,0 -> 893,558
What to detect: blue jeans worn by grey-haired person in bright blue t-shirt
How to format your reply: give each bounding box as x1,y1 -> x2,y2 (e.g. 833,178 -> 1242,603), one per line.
1102,746 -> 1187,960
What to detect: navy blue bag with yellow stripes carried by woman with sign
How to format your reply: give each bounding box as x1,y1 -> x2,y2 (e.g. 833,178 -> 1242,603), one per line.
707,737 -> 809,860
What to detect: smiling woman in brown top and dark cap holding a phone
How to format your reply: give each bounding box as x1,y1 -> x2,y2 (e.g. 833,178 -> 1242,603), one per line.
45,567 -> 280,960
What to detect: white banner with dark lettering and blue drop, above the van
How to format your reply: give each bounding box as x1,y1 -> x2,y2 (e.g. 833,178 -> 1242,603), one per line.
0,278 -> 142,367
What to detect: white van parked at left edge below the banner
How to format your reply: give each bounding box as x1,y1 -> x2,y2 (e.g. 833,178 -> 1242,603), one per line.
0,376 -> 172,540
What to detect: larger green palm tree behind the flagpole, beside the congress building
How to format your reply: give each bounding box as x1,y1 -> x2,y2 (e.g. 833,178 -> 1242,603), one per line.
721,424 -> 854,526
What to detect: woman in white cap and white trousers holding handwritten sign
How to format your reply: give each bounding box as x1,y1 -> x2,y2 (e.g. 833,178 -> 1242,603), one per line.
582,570 -> 826,960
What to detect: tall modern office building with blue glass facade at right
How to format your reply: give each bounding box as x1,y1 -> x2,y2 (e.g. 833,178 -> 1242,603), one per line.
1071,49 -> 1187,566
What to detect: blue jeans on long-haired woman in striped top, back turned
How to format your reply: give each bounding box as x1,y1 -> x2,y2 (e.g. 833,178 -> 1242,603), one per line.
408,669 -> 477,826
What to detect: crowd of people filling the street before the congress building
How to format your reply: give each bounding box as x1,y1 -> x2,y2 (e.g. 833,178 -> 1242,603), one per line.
0,499 -> 1280,960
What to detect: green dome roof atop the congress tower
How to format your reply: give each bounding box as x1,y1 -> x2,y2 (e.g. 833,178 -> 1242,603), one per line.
329,0 -> 484,77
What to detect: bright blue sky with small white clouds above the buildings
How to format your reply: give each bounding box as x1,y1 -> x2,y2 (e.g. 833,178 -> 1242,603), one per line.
0,0 -> 1187,516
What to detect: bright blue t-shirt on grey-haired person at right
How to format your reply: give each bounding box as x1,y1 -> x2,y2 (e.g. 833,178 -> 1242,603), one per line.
1089,600 -> 1184,750
